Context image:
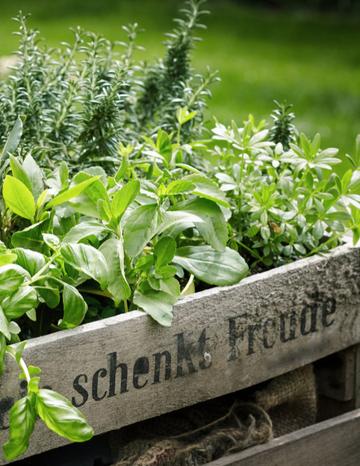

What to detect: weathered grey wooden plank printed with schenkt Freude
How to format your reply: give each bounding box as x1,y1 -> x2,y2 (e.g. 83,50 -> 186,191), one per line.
0,246 -> 360,464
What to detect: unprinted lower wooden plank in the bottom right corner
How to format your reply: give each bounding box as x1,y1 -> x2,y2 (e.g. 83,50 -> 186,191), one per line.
208,410 -> 360,466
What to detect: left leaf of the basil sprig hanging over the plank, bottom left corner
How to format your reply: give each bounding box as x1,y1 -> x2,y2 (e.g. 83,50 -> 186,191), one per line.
3,394 -> 36,461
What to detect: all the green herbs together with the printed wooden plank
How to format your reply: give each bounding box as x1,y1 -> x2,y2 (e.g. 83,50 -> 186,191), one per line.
0,0 -> 360,464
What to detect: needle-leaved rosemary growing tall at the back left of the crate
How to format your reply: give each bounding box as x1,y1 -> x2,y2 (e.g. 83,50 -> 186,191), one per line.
0,0 -> 216,169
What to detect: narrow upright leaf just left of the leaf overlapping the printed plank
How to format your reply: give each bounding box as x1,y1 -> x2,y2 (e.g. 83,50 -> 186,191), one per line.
100,238 -> 131,306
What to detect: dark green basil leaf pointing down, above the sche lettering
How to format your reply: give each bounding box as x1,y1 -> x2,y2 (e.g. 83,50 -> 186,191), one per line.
58,283 -> 88,329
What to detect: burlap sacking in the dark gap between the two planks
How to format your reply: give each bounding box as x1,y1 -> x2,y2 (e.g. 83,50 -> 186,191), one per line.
111,366 -> 316,466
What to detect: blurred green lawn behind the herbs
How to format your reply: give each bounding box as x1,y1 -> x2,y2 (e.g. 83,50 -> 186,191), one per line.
0,0 -> 360,151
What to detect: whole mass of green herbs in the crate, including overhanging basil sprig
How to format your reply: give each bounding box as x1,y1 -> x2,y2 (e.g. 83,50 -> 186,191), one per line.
0,0 -> 360,460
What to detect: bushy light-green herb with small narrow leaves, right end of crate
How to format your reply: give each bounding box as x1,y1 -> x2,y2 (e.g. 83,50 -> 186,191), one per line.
204,107 -> 360,270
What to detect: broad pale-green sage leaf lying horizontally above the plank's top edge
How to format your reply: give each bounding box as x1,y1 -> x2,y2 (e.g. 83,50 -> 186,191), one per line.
173,246 -> 249,286
